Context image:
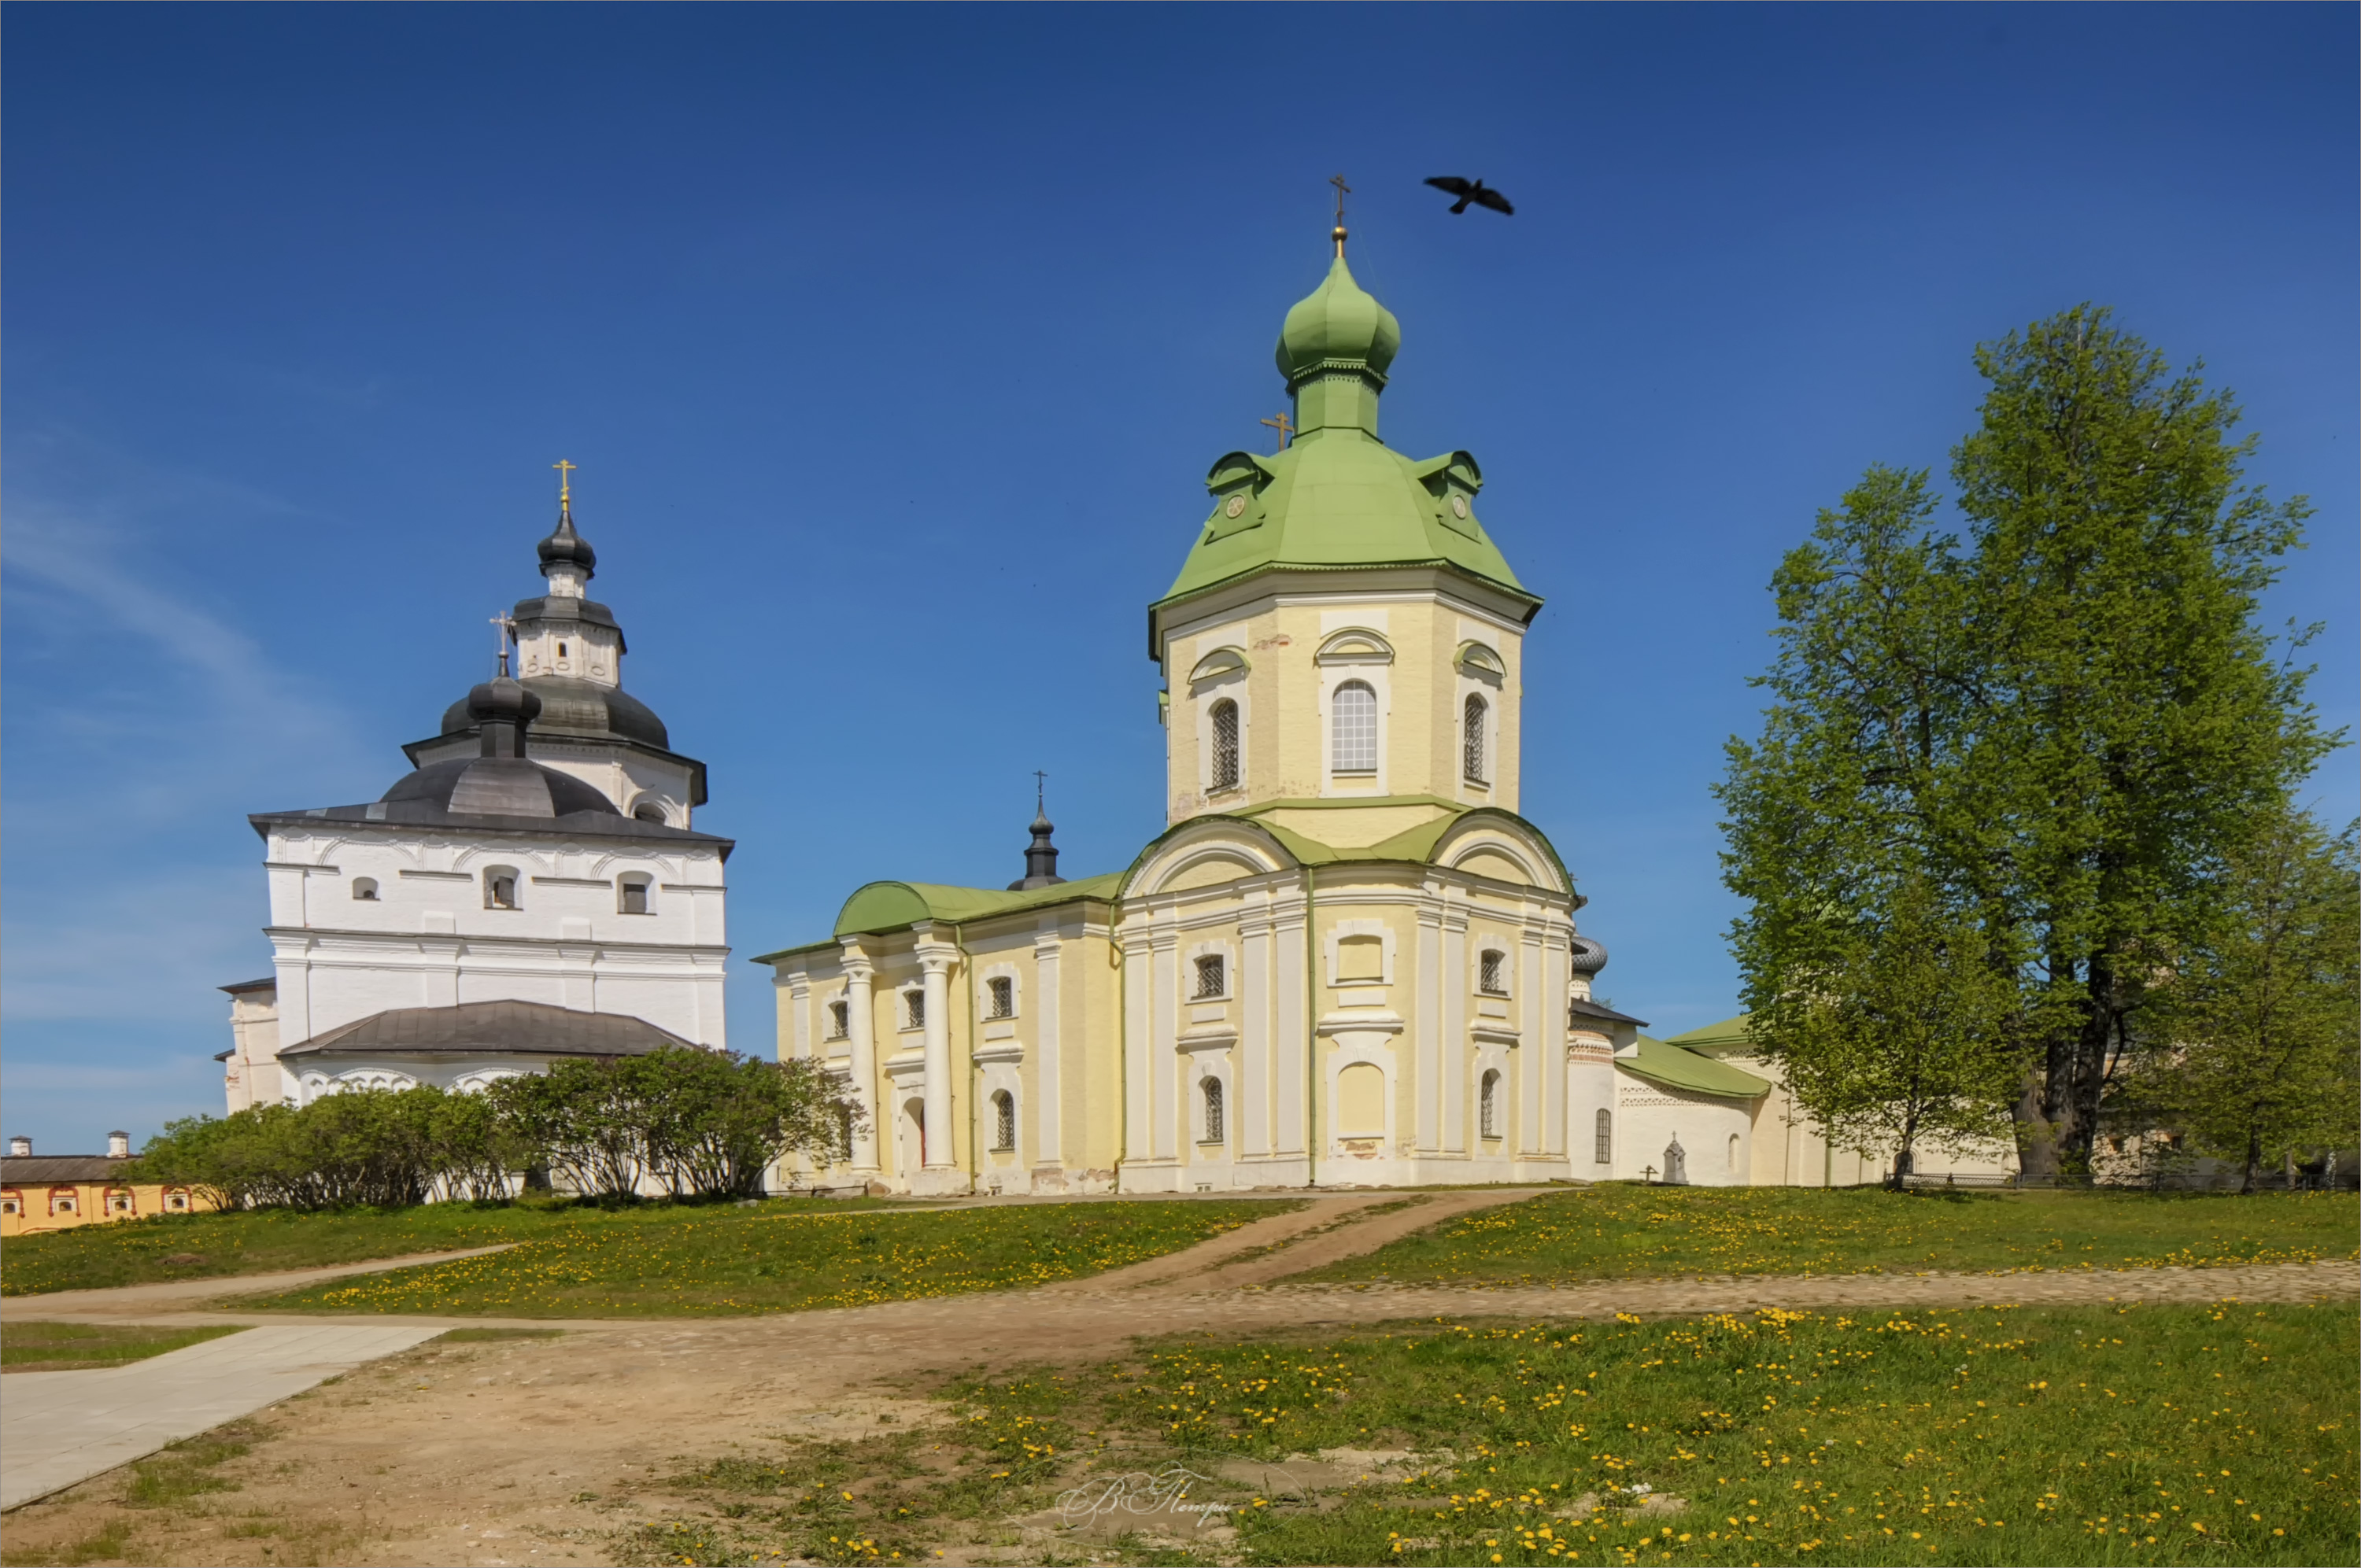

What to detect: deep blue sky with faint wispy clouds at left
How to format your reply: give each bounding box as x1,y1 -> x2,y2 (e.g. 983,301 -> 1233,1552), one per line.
0,5 -> 2361,1150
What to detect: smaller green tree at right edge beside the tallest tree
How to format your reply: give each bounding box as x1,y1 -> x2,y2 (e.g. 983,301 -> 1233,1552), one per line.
2132,813 -> 2361,1193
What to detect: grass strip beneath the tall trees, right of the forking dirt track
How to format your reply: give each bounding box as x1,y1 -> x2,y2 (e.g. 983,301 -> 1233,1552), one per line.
1299,1186 -> 2361,1285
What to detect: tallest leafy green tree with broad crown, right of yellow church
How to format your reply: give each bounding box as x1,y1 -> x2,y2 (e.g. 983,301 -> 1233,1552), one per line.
1719,307 -> 2335,1174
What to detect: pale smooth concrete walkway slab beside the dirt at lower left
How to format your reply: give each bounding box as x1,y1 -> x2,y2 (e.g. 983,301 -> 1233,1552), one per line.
0,1323 -> 444,1509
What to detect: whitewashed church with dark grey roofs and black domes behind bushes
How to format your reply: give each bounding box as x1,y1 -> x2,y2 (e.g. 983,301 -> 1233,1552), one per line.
220,484 -> 732,1110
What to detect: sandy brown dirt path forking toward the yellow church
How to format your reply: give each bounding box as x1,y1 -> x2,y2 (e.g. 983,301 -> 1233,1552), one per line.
9,1193 -> 2361,1566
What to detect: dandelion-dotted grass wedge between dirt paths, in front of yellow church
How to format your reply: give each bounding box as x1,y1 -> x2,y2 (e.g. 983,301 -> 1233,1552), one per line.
223,1200 -> 1296,1318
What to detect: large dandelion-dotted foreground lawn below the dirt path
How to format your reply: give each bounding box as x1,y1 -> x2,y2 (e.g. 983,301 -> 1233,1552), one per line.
623,1304 -> 2361,1566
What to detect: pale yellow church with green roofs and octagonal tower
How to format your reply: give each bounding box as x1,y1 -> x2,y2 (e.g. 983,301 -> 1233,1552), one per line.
758,227 -> 1804,1195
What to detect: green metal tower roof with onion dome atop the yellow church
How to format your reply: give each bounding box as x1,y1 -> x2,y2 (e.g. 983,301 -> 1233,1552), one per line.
1147,255 -> 1542,651
